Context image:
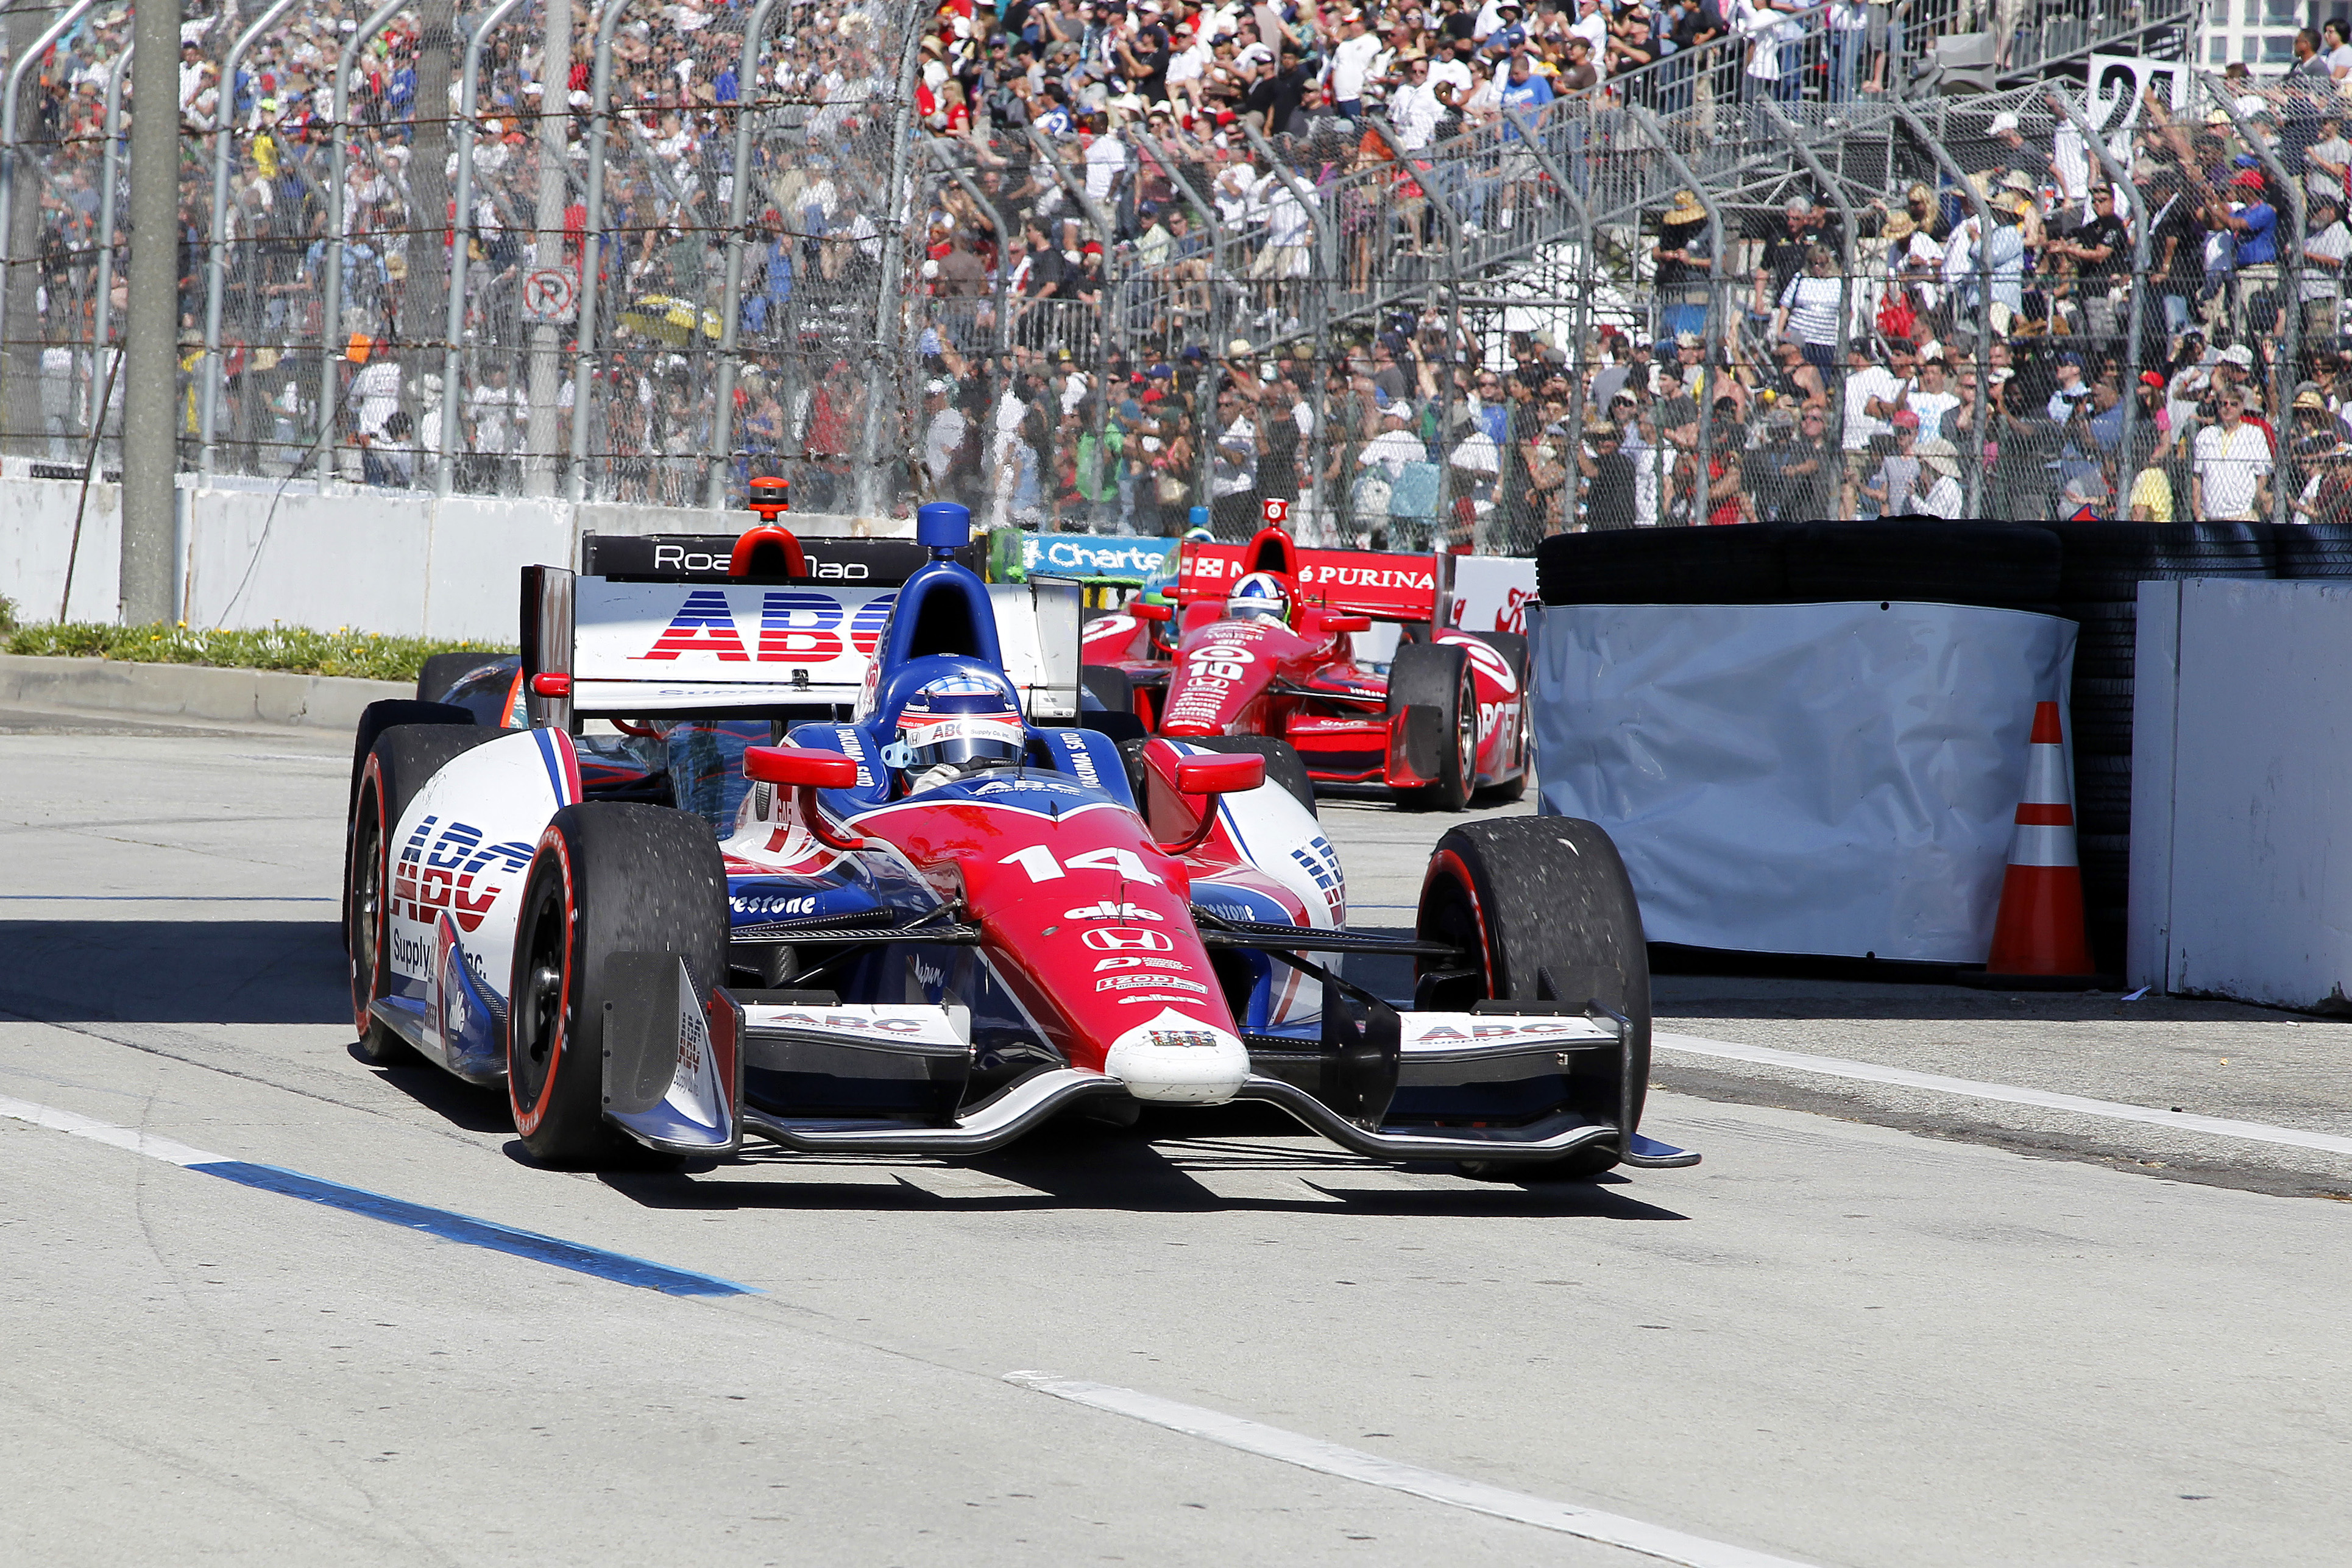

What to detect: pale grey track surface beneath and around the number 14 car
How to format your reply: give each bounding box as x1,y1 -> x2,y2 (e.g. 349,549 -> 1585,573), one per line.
0,715 -> 2352,1568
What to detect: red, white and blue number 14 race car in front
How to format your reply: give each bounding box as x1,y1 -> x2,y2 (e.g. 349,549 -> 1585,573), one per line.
344,506 -> 1696,1176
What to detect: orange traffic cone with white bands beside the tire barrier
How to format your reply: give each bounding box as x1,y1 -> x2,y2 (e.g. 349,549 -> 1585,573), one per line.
1985,703 -> 2098,990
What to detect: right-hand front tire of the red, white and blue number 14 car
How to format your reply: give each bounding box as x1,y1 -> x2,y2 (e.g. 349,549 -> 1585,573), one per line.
1414,816 -> 1649,1180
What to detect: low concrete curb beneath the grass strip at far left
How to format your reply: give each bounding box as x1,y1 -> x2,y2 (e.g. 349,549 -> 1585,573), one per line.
0,654 -> 416,731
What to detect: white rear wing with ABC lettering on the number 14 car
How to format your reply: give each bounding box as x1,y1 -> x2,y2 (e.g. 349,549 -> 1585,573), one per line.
522,564 -> 1084,726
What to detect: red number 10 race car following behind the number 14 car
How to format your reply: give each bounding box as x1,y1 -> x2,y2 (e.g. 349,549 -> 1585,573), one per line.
1084,515 -> 1529,811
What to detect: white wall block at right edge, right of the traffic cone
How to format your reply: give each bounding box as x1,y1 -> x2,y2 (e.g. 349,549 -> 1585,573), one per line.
2126,578 -> 2352,1006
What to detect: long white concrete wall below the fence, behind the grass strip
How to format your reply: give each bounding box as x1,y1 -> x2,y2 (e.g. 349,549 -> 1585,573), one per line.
0,461 -> 913,642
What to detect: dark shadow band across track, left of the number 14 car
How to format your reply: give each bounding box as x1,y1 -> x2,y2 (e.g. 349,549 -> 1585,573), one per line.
0,919 -> 350,1025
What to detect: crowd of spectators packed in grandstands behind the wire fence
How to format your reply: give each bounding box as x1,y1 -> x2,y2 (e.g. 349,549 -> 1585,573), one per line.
0,0 -> 2276,550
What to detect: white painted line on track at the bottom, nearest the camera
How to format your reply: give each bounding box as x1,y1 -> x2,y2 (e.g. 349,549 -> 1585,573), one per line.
1004,1373 -> 1808,1568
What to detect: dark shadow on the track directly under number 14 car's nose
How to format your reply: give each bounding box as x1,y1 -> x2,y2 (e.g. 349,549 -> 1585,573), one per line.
600,1119 -> 1687,1220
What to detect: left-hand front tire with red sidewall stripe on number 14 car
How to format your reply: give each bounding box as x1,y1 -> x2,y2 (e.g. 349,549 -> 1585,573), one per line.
506,802 -> 727,1168
